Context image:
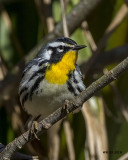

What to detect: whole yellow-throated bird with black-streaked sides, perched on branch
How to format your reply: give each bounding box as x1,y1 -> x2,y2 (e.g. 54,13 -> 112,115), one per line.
19,37 -> 86,119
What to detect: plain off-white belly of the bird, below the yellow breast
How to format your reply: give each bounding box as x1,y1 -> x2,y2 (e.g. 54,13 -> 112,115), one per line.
24,80 -> 74,119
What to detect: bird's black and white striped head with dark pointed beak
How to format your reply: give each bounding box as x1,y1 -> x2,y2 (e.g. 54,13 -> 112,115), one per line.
37,37 -> 86,63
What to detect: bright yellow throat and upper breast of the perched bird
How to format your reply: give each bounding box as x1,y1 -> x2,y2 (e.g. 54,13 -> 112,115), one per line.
45,51 -> 77,84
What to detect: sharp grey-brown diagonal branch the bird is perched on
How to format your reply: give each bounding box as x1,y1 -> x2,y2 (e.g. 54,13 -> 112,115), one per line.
0,57 -> 128,160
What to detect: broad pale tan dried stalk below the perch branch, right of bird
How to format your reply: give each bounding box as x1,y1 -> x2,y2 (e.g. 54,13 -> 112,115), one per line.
82,97 -> 108,160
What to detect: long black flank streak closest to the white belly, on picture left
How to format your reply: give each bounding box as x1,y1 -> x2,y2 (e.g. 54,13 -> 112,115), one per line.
29,76 -> 44,100
